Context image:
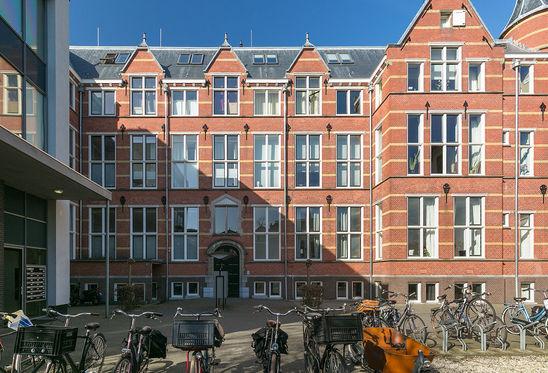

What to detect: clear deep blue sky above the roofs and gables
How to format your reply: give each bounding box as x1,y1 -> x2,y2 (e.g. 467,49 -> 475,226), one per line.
70,0 -> 515,47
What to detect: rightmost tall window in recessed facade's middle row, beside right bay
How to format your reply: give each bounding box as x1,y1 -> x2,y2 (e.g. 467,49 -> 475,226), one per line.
337,135 -> 362,188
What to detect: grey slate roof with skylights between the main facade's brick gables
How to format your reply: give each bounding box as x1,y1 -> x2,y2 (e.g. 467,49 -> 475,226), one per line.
70,46 -> 385,79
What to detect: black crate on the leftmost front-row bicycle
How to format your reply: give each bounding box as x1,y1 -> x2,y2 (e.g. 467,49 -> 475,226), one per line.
15,326 -> 78,356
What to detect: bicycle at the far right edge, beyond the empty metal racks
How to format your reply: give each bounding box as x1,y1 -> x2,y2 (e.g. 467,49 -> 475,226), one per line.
502,288 -> 548,335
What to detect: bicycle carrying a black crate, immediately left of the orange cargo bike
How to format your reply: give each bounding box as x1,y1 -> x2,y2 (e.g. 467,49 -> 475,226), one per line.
299,304 -> 363,373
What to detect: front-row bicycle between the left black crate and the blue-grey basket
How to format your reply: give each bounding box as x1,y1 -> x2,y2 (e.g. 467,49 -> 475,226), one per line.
111,310 -> 163,373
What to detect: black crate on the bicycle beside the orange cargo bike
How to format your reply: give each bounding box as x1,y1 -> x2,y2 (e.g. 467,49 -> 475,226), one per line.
313,315 -> 363,344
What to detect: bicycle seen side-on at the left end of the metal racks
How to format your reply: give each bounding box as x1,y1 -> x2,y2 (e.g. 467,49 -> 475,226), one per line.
431,285 -> 497,337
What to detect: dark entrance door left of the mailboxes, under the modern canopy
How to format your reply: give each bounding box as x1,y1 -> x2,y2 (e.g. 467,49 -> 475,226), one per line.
4,249 -> 23,312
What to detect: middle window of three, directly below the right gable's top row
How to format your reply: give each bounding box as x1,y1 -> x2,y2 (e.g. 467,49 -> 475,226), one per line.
430,114 -> 460,175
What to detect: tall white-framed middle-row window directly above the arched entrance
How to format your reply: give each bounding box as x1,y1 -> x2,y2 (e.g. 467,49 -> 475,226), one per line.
213,135 -> 239,188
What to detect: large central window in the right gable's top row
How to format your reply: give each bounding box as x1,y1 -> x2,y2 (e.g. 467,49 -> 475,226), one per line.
430,47 -> 460,91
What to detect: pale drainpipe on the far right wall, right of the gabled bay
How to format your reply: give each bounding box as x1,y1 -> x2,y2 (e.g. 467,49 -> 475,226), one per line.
512,60 -> 521,297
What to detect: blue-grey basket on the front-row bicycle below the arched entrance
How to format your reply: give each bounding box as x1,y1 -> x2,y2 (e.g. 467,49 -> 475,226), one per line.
171,320 -> 215,350
